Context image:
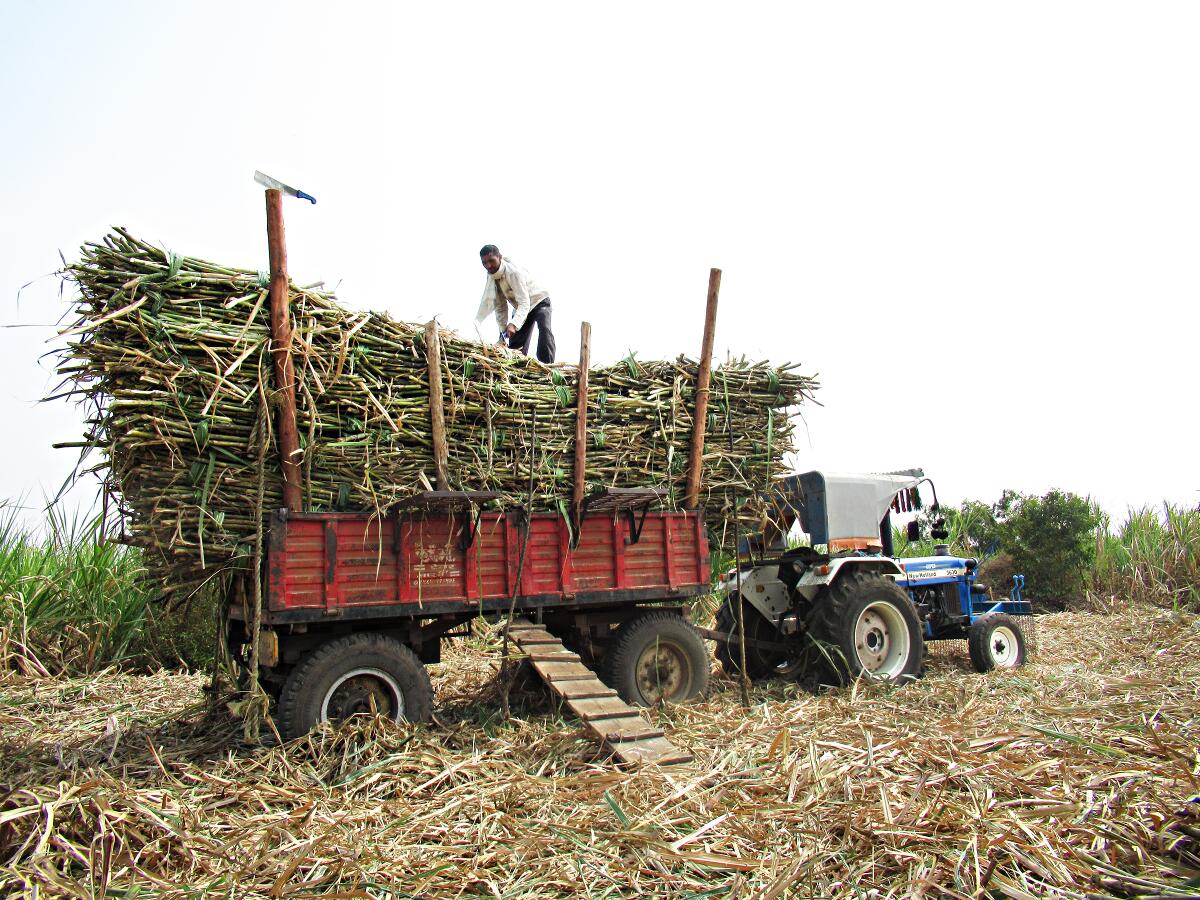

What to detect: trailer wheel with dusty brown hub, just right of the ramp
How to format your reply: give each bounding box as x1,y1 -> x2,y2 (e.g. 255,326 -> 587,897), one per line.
605,612 -> 709,707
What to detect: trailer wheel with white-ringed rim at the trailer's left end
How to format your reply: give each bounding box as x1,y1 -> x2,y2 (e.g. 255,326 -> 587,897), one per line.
278,632 -> 433,740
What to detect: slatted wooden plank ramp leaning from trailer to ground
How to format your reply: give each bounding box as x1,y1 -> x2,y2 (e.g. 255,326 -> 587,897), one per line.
509,619 -> 691,766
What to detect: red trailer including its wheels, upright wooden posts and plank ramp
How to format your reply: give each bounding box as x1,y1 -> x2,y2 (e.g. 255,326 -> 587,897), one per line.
224,217 -> 721,762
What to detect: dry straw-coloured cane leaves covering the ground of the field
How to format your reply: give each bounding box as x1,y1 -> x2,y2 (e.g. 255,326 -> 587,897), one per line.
0,608 -> 1200,898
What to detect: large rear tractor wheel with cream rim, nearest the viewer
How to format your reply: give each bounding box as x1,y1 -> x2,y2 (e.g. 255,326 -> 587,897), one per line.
810,571 -> 924,683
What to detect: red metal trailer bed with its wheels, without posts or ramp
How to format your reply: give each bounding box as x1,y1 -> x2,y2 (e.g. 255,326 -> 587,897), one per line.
228,488 -> 710,738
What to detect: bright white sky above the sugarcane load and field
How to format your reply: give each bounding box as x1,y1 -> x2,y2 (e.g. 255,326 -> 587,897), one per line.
0,0 -> 1200,528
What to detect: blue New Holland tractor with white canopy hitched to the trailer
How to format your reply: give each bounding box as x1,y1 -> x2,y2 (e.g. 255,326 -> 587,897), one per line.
709,469 -> 1032,683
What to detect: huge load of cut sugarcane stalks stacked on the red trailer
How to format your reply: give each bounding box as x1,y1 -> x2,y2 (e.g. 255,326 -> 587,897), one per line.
55,229 -> 817,600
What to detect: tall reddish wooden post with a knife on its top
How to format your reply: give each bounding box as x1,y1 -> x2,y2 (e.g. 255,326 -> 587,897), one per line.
266,190 -> 302,512
